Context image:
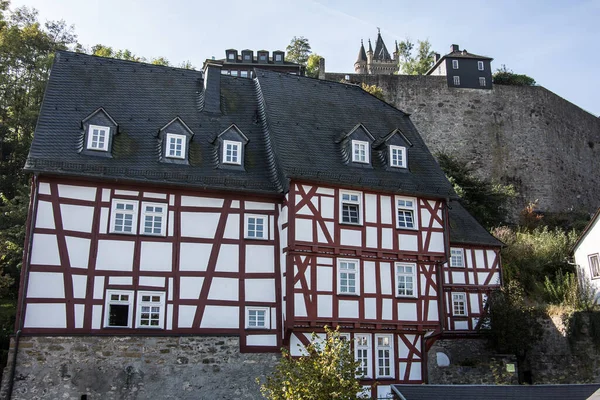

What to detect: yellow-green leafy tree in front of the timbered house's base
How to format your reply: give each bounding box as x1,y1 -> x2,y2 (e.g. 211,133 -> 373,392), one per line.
257,327 -> 361,400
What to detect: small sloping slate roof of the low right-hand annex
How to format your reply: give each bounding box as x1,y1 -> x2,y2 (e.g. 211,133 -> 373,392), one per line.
448,200 -> 504,246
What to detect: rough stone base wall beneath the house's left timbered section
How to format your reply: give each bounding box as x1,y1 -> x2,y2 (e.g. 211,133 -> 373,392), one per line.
1,336 -> 279,400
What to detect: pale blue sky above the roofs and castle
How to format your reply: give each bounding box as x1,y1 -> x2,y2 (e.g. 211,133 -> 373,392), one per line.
11,0 -> 600,116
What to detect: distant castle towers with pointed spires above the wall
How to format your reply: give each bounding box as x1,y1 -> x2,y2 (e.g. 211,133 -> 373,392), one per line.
354,30 -> 398,75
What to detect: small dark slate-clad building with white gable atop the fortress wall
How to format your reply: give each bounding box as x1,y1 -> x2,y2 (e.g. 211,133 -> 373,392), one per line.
425,44 -> 493,89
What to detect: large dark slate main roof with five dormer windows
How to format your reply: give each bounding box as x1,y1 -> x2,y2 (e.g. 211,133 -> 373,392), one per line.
25,52 -> 455,198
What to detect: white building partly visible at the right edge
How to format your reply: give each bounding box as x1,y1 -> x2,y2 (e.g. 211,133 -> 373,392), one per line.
573,208 -> 600,303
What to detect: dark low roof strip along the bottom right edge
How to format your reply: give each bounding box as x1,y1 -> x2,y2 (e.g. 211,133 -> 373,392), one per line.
392,383 -> 600,400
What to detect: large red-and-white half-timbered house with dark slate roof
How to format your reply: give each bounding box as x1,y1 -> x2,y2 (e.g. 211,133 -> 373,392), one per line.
8,52 -> 500,397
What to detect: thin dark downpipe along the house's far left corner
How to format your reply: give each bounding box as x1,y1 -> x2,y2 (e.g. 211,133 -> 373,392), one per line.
6,174 -> 39,400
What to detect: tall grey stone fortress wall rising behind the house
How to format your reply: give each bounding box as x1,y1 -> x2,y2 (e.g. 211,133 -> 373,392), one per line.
326,73 -> 600,219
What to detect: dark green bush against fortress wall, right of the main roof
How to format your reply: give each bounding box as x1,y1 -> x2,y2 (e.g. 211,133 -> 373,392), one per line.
436,153 -> 517,229
